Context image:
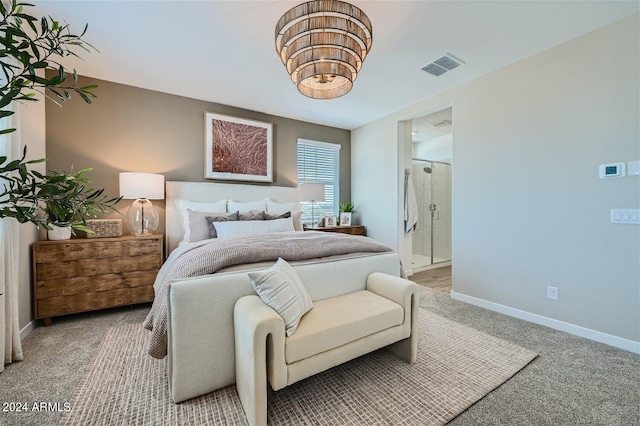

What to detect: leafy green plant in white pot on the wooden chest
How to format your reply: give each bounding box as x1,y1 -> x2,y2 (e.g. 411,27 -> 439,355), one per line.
34,169 -> 122,240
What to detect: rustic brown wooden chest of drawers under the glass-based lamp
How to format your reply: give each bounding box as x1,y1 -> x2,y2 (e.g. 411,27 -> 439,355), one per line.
32,235 -> 163,325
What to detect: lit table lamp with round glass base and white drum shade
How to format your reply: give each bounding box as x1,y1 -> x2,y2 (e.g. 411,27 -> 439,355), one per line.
120,172 -> 164,237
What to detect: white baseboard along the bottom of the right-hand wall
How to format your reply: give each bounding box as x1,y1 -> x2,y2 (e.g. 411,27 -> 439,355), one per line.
451,291 -> 640,354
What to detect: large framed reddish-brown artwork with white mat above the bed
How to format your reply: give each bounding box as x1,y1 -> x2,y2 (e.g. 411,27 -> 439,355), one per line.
204,112 -> 273,182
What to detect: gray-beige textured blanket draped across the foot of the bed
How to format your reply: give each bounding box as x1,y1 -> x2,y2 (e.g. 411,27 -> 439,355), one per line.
144,232 -> 391,359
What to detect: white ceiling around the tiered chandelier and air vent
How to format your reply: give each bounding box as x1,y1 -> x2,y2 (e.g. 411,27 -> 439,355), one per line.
32,0 -> 639,129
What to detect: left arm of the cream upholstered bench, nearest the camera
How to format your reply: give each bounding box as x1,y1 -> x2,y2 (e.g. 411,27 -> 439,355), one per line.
233,296 -> 287,425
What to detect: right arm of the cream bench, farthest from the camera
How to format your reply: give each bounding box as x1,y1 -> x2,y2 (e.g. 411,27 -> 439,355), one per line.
367,272 -> 420,363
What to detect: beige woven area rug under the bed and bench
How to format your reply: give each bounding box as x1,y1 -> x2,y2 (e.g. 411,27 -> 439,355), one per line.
59,309 -> 537,425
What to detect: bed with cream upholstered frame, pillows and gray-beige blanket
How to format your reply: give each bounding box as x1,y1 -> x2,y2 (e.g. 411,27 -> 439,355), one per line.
145,181 -> 401,402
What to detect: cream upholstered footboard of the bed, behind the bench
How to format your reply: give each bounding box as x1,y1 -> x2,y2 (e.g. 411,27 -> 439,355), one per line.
167,252 -> 401,402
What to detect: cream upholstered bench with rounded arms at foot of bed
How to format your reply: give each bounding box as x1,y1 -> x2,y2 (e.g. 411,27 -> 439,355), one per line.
234,272 -> 419,425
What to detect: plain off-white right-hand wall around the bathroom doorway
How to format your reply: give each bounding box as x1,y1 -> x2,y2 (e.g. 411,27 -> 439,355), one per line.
352,14 -> 640,351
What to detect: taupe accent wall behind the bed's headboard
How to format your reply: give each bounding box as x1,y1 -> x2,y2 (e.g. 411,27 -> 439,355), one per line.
46,77 -> 351,236
